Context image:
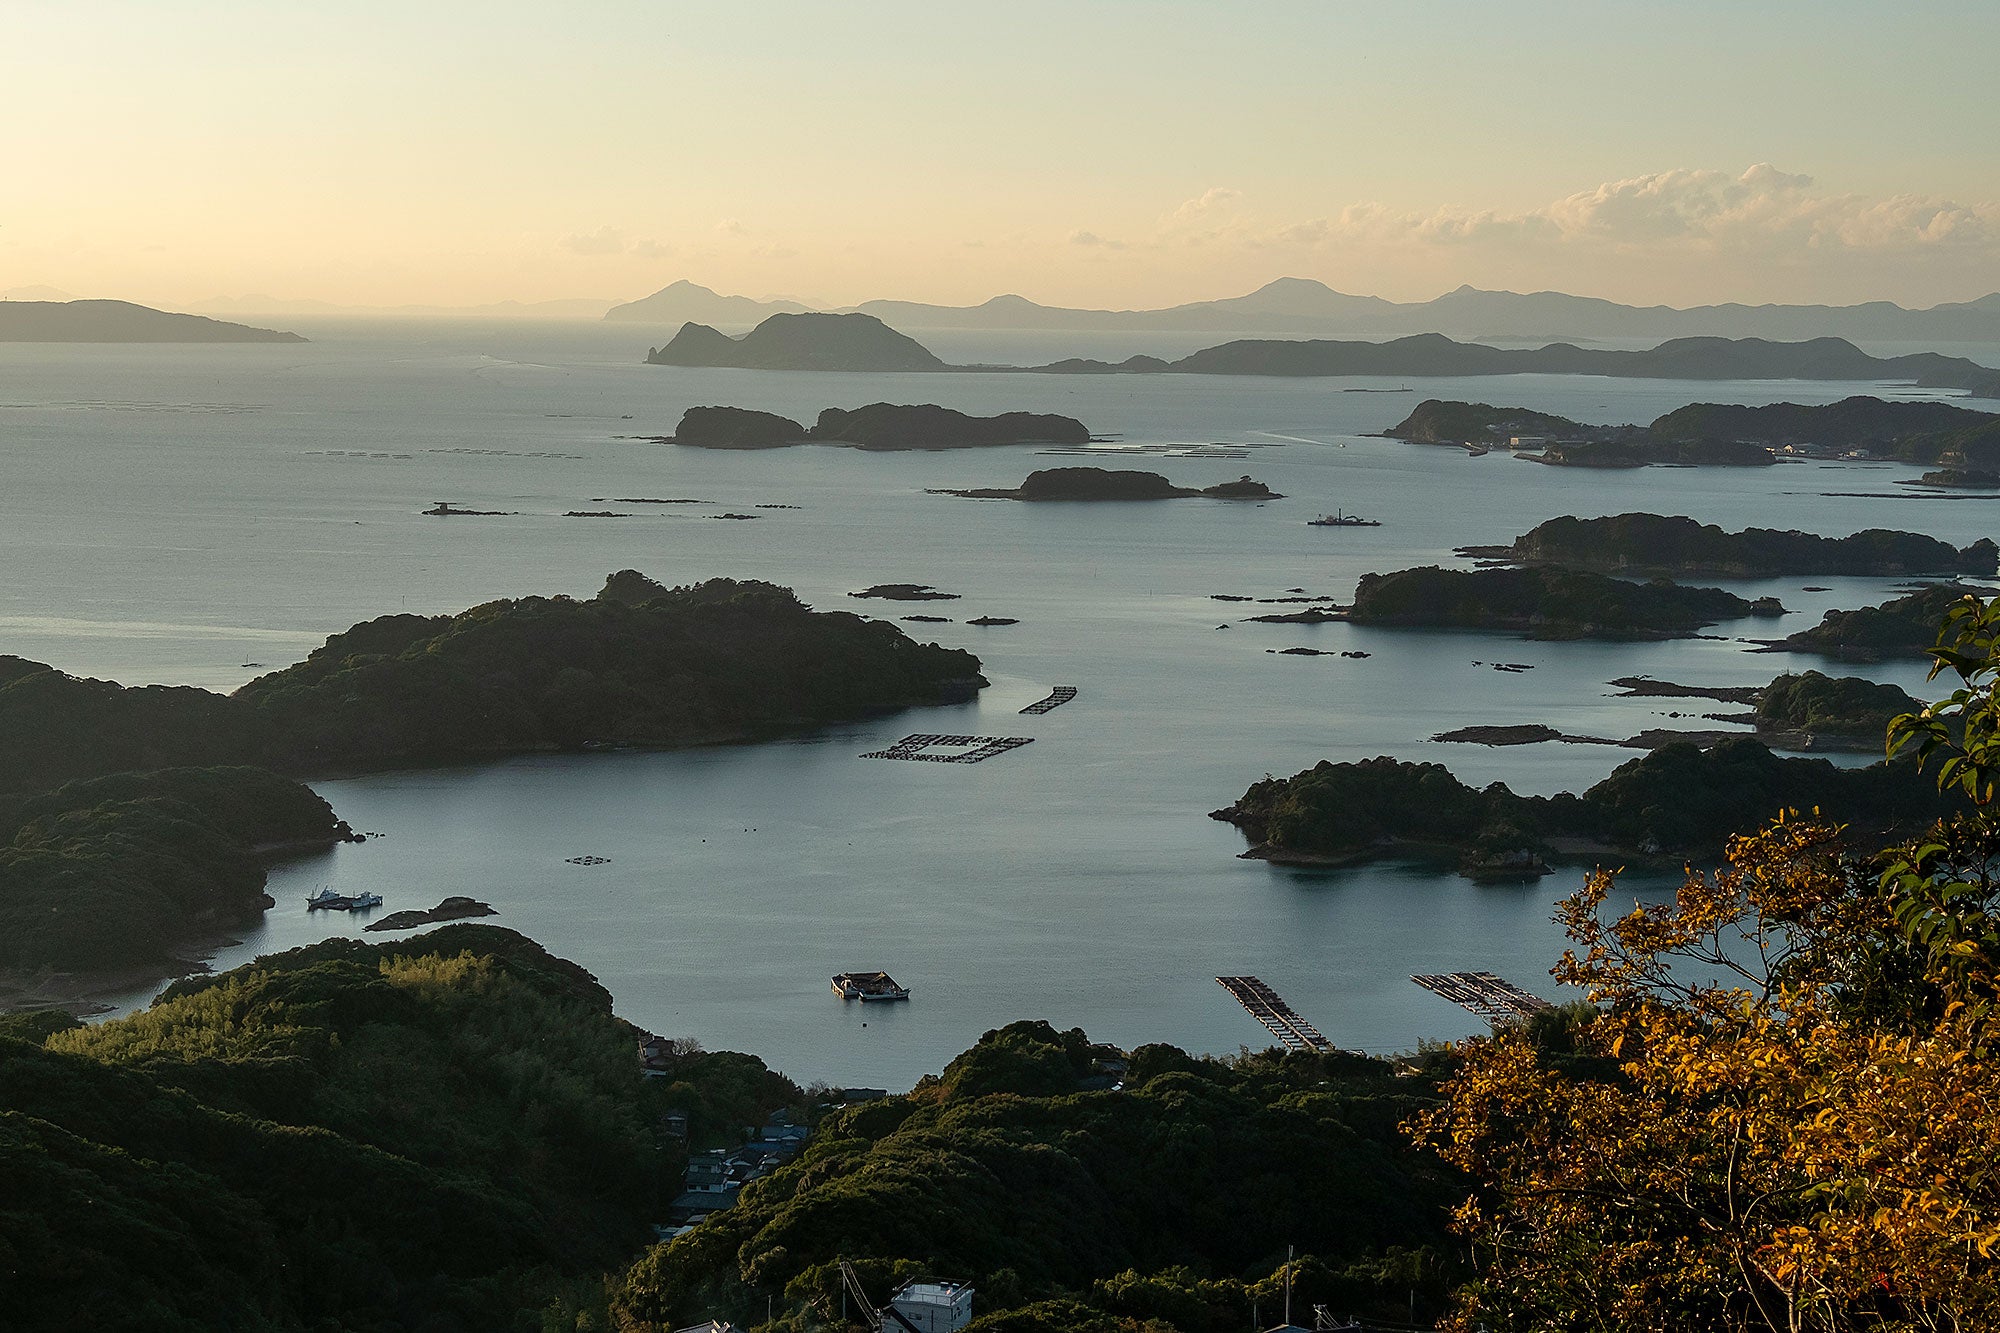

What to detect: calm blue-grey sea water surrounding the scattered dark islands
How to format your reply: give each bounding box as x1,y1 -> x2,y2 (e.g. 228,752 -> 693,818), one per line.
0,322 -> 1996,1087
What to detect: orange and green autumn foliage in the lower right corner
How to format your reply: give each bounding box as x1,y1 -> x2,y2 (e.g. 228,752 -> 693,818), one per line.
1412,598 -> 2000,1333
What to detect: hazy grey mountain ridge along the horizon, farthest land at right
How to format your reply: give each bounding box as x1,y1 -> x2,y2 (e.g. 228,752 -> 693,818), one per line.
604,278 -> 2000,342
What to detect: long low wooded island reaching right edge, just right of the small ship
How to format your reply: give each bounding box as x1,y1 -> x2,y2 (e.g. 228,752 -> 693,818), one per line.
1458,514 -> 2000,578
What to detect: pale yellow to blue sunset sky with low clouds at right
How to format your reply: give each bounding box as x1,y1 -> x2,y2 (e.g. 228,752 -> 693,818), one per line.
0,0 -> 2000,306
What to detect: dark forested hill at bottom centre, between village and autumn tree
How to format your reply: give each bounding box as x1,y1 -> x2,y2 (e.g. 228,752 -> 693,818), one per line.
616,1023 -> 1462,1333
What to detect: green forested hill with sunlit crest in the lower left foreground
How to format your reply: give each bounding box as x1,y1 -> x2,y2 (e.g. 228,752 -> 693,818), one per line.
0,925 -> 800,1333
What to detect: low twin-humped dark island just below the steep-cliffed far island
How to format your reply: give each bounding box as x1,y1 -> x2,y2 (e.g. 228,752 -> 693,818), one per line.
654,402 -> 1090,450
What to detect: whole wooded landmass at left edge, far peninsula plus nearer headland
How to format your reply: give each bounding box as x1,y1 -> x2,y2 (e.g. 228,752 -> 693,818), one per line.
0,570 -> 986,1001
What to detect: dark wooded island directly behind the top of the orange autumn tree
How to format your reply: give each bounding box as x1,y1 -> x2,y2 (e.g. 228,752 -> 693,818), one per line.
1214,737 -> 1966,877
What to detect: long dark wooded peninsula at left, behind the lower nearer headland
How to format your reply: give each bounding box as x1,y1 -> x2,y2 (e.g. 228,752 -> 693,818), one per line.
0,570 -> 986,793
